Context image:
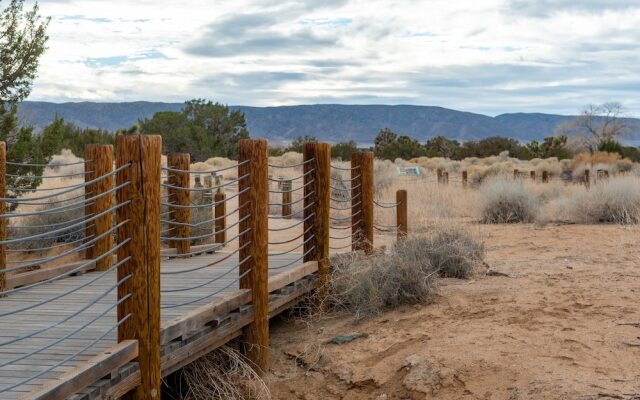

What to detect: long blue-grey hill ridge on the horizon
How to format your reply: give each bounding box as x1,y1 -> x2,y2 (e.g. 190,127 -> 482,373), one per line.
18,101 -> 640,144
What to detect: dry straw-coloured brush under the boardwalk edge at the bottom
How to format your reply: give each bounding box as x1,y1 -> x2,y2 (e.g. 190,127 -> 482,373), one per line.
183,346 -> 271,400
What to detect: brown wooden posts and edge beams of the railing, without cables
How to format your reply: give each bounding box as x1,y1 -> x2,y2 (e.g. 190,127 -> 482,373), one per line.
0,135 -> 409,399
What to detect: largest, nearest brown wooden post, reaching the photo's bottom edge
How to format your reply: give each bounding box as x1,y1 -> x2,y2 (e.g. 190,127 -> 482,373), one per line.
116,135 -> 162,400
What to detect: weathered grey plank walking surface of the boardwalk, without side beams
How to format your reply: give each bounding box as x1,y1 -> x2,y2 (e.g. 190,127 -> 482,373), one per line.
0,253 -> 313,399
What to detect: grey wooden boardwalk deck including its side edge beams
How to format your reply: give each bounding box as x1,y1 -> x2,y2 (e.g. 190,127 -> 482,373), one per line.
0,253 -> 317,399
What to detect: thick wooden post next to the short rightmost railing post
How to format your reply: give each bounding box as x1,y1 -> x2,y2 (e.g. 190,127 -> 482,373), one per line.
351,152 -> 373,253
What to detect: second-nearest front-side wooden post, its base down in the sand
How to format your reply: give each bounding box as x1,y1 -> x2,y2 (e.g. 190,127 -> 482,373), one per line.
238,139 -> 269,374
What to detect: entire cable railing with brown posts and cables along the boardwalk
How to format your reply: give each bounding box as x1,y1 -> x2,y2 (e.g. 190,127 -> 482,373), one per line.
0,135 -> 406,398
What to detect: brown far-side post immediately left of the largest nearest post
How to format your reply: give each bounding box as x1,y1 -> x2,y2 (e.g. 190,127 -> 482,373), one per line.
84,144 -> 114,271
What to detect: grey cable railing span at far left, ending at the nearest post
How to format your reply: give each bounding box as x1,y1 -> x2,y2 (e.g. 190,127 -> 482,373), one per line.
0,155 -> 133,398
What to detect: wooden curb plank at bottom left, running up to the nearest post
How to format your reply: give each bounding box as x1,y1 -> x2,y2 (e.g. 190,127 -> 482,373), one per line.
21,340 -> 138,400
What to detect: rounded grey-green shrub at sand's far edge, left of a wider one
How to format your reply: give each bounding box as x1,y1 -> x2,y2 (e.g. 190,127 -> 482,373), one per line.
480,177 -> 540,224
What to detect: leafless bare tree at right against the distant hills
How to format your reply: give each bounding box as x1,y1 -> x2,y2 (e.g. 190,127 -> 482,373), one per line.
556,102 -> 629,153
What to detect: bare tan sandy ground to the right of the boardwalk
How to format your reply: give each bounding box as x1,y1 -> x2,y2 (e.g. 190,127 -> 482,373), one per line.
269,225 -> 640,400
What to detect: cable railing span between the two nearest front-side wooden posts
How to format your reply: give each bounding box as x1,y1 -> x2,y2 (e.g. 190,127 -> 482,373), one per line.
160,160 -> 260,312
